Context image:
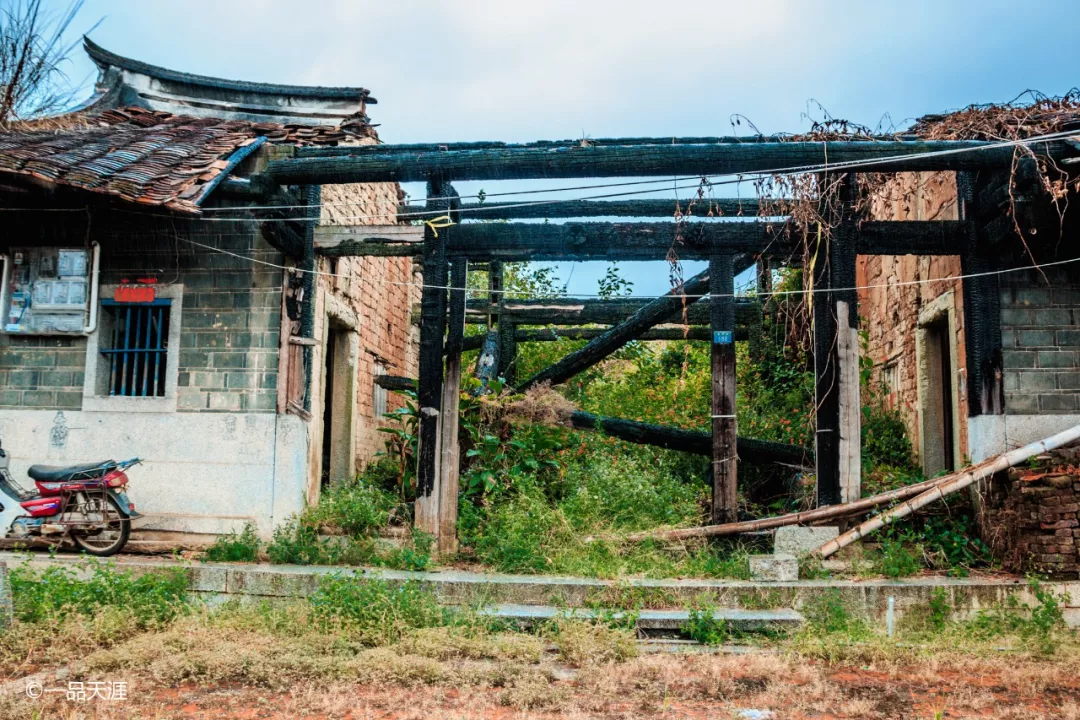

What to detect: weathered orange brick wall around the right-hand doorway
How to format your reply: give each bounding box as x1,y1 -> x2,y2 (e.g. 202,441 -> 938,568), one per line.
855,173 -> 968,452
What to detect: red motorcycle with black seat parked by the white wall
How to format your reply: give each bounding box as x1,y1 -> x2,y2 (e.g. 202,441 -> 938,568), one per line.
0,440 -> 141,557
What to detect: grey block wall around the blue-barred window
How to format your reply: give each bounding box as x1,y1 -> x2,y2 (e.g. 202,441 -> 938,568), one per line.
0,213 -> 283,412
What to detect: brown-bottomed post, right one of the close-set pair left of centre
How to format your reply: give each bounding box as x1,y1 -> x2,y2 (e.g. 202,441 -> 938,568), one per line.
437,258 -> 468,553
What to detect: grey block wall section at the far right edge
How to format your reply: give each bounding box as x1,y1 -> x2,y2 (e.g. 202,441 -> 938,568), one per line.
1001,268 -> 1080,415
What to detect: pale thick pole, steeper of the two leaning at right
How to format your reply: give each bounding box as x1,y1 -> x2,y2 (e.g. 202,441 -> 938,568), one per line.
813,425 -> 1080,558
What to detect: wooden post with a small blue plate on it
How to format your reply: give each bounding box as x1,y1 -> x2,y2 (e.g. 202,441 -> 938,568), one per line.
708,255 -> 739,524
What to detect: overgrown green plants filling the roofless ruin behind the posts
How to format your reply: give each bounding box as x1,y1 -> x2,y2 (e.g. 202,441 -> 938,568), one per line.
252,266 -> 989,579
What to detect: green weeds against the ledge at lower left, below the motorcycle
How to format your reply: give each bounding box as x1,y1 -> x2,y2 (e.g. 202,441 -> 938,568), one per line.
9,562 -> 188,627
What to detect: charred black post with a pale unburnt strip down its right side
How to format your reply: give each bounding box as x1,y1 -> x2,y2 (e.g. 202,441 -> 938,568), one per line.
812,174 -> 861,505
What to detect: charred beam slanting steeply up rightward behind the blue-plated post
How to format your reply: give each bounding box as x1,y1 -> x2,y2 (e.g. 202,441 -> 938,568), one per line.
517,271 -> 712,392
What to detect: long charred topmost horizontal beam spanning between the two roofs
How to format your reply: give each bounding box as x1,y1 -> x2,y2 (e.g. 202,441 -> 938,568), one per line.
266,139 -> 1077,185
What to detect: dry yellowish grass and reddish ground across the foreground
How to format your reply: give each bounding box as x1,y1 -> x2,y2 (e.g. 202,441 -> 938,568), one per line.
6,608 -> 1080,720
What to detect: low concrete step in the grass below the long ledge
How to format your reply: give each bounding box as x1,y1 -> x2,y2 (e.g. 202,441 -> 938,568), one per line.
480,603 -> 804,631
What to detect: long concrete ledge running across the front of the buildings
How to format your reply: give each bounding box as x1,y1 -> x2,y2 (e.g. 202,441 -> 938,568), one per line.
0,553 -> 1080,625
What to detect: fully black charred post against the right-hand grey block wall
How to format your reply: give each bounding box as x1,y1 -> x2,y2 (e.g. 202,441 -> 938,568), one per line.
956,173 -> 1004,418
